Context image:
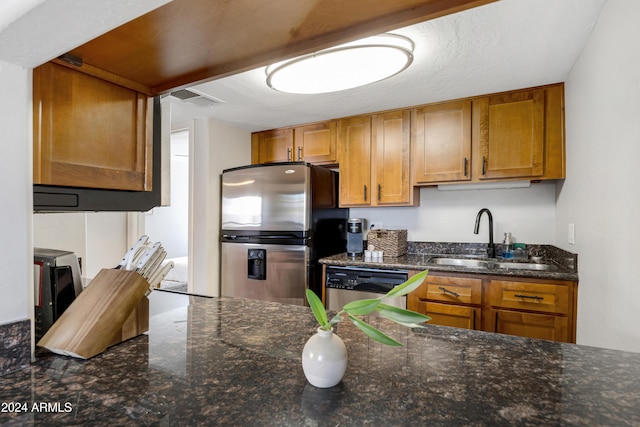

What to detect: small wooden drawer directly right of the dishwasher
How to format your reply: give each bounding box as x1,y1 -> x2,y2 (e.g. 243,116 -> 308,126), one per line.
418,275 -> 482,304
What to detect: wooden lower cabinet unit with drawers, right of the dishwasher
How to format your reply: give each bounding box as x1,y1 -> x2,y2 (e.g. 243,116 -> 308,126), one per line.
407,272 -> 577,343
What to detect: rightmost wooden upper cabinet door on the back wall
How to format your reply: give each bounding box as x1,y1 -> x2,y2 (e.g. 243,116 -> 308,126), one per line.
473,89 -> 545,180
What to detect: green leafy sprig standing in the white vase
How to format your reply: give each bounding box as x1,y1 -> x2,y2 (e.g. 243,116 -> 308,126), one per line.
307,270 -> 431,346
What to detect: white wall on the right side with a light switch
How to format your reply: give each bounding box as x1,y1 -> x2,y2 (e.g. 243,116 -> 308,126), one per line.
556,0 -> 640,351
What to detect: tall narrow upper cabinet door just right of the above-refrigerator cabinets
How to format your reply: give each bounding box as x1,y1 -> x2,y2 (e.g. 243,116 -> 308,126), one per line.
338,116 -> 372,206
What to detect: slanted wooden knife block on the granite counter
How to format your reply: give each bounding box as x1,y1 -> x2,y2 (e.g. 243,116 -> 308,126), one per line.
38,269 -> 149,359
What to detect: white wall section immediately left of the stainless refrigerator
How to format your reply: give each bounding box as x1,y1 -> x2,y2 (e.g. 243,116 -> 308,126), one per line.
189,119 -> 251,296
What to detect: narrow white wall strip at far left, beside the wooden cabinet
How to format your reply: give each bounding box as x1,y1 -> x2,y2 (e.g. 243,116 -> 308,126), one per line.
0,61 -> 33,324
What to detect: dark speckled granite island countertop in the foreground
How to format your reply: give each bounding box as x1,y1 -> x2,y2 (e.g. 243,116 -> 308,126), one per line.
0,291 -> 640,426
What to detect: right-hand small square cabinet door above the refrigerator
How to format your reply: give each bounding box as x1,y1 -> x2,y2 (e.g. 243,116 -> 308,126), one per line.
294,121 -> 338,165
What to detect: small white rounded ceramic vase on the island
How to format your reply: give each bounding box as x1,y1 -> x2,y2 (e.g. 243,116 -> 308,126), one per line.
302,328 -> 347,388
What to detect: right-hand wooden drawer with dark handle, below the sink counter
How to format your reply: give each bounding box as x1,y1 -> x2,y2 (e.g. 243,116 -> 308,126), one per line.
489,280 -> 569,314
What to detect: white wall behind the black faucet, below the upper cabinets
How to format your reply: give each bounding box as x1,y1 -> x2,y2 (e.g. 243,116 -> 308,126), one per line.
350,182 -> 556,244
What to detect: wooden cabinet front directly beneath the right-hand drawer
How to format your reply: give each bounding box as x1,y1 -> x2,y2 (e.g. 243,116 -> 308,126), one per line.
492,310 -> 570,342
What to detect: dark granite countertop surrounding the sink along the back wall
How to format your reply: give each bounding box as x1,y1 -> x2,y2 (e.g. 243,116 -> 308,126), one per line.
319,242 -> 578,282
